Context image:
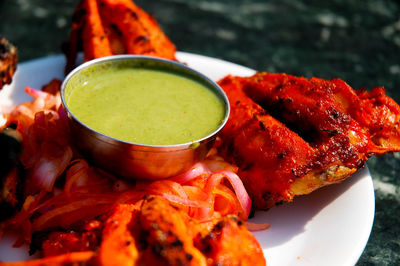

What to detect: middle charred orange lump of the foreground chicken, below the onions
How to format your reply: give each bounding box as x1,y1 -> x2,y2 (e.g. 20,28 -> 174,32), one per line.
138,197 -> 207,265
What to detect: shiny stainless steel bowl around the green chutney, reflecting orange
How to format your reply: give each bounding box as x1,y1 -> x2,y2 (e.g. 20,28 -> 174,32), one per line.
61,55 -> 230,180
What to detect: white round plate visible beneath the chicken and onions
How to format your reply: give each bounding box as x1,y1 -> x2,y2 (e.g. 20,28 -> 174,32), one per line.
0,52 -> 375,266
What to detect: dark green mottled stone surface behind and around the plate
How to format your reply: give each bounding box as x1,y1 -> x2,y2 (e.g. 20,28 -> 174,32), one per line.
0,0 -> 400,265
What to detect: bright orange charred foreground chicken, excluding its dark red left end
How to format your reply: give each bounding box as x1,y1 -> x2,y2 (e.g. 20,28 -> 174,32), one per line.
95,196 -> 265,265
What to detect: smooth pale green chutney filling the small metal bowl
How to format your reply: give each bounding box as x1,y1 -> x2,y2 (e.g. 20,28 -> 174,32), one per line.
66,67 -> 226,145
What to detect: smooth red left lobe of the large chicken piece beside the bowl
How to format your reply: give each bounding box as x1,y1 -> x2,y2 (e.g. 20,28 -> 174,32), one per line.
219,76 -> 314,208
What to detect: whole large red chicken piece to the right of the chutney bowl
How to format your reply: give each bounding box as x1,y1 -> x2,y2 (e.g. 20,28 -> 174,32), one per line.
219,73 -> 400,209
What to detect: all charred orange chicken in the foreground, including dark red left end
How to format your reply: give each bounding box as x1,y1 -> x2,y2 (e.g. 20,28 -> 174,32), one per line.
28,196 -> 266,266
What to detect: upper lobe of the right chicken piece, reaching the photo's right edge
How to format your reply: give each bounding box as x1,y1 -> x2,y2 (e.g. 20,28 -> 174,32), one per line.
244,73 -> 400,154
